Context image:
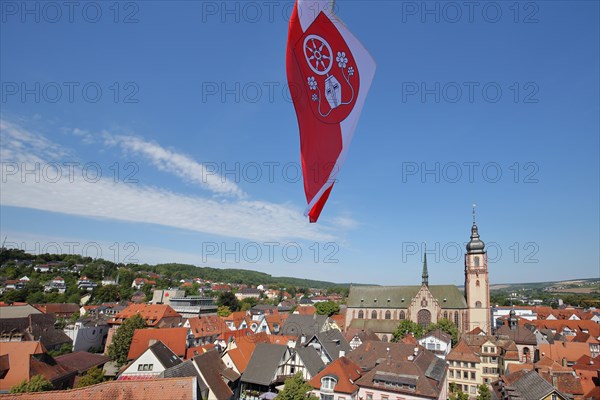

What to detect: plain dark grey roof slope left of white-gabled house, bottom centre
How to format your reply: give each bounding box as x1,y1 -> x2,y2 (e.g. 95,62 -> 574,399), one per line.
242,343 -> 287,386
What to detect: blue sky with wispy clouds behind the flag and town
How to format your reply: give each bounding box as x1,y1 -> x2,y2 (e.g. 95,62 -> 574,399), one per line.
0,0 -> 600,284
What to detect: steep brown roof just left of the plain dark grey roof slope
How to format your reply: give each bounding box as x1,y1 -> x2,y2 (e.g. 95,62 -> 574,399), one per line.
193,350 -> 240,400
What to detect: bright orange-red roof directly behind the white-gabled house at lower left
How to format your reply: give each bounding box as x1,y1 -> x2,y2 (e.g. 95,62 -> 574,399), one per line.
127,328 -> 187,360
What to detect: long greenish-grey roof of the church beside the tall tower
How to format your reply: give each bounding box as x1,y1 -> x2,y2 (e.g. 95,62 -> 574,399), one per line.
347,285 -> 467,309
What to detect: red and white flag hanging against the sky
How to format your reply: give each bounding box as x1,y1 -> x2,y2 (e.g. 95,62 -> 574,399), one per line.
287,0 -> 375,222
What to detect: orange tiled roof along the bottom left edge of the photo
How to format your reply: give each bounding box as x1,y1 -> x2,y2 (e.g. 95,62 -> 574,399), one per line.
0,377 -> 196,400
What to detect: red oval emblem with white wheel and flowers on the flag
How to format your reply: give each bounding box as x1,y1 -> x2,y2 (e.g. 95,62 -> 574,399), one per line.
294,12 -> 360,124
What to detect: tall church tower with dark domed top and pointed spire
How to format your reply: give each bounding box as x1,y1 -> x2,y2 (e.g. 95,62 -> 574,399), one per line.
465,205 -> 492,334
